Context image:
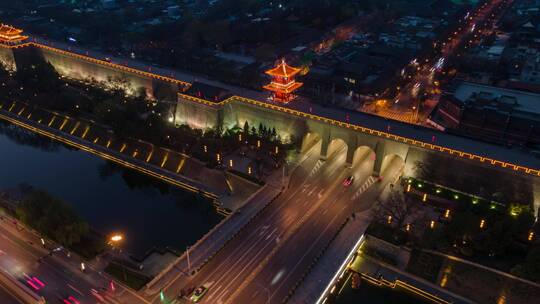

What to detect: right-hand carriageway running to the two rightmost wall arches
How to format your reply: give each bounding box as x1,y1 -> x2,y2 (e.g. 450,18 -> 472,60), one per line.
232,151 -> 402,303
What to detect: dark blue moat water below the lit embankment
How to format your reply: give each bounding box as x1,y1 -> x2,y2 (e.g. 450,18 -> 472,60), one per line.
0,121 -> 222,257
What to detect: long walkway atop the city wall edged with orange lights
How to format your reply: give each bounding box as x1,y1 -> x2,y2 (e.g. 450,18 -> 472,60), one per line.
4,37 -> 540,176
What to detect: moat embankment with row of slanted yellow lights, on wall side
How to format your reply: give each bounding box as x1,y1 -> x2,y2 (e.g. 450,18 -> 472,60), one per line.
0,102 -> 260,214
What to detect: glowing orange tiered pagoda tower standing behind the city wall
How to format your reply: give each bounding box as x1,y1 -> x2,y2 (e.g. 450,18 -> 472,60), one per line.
264,59 -> 302,103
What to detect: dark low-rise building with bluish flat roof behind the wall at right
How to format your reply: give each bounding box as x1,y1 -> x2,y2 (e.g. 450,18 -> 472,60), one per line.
431,82 -> 540,145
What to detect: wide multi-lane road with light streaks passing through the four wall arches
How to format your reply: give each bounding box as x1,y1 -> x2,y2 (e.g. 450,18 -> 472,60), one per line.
153,139 -> 401,304
